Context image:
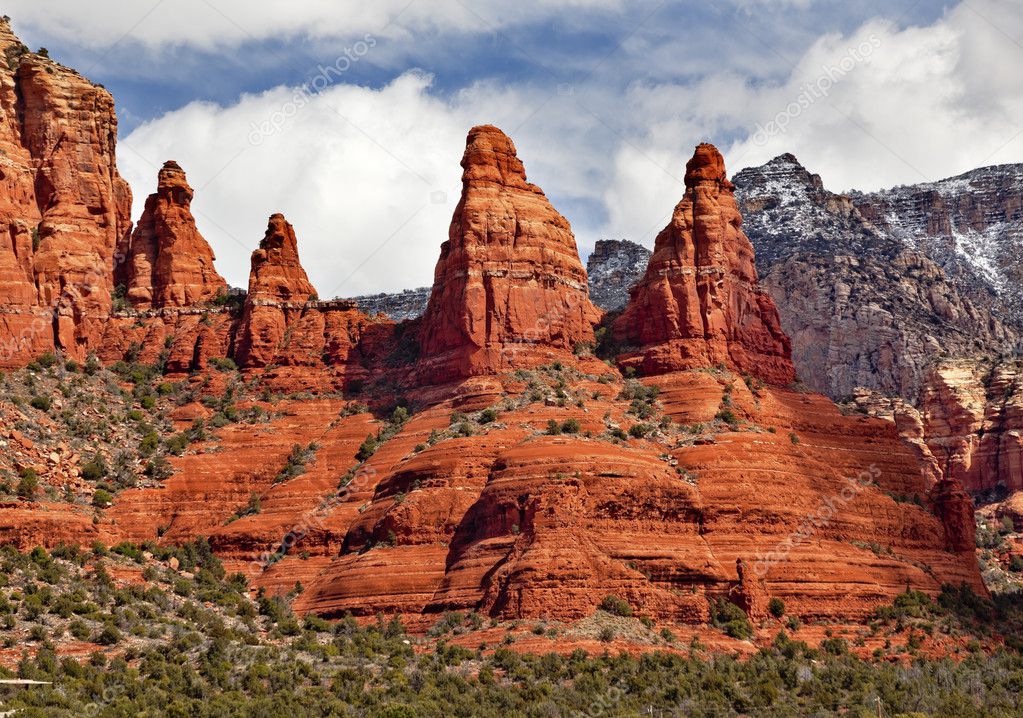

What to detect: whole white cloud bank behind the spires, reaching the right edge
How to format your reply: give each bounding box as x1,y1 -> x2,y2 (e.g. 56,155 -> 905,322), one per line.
120,0 -> 1023,297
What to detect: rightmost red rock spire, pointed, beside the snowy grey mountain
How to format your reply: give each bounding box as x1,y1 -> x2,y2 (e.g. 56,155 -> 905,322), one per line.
614,144 -> 795,385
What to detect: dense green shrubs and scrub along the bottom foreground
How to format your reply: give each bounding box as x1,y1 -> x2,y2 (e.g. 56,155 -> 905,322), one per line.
0,541 -> 1023,718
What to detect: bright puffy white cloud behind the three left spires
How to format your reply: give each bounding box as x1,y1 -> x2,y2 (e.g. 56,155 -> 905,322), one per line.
119,72 -> 599,298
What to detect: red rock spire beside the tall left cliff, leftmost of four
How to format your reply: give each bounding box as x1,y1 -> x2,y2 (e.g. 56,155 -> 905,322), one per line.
122,162 -> 227,309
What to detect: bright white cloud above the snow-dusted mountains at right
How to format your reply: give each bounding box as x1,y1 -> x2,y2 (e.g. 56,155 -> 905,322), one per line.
728,0 -> 1023,189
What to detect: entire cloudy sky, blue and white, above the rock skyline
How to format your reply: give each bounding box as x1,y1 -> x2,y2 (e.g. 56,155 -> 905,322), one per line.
4,0 -> 1023,298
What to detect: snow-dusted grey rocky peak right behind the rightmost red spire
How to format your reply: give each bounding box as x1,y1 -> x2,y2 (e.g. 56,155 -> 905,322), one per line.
735,154 -> 1019,402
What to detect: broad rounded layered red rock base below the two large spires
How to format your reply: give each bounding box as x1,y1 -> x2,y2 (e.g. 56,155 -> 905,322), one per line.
290,372 -> 983,623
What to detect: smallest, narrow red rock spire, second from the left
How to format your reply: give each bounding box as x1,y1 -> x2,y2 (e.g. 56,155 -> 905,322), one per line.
235,214 -> 316,367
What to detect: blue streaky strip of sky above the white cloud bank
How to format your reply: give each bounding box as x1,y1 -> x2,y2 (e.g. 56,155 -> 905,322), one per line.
11,0 -> 954,133
